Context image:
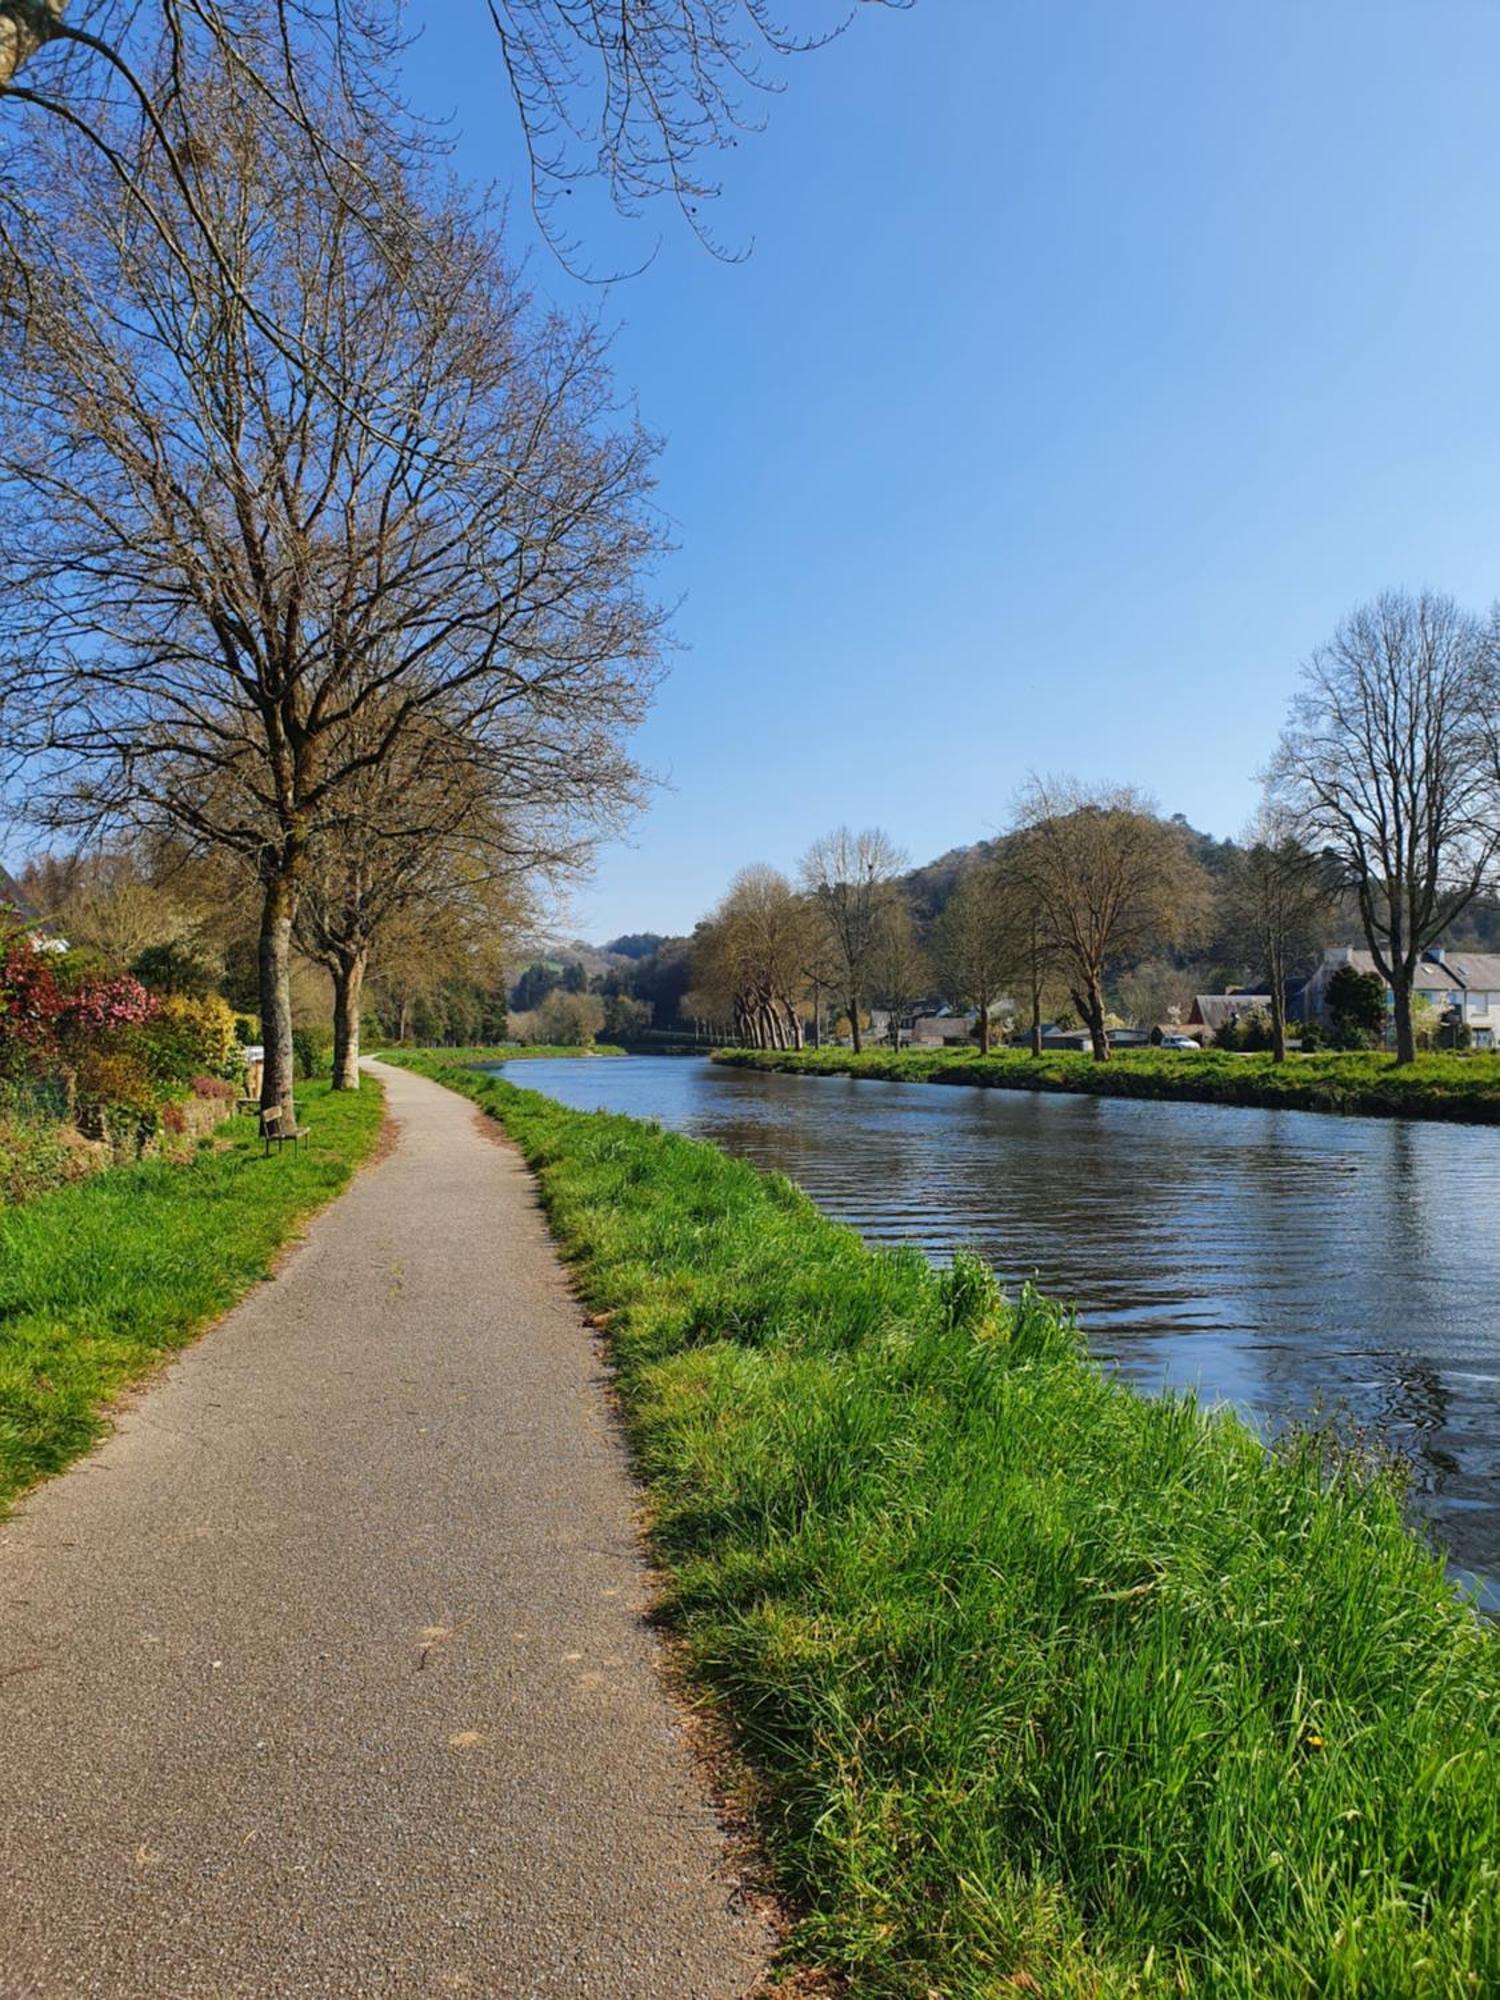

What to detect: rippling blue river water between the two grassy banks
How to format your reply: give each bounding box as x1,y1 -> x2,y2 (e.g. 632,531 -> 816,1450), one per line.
496,1056 -> 1500,1610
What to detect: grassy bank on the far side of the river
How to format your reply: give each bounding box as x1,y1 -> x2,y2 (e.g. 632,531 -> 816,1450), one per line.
714,1048 -> 1500,1124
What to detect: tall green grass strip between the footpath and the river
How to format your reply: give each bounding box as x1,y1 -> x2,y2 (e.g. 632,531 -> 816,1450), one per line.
384,1058 -> 1500,2000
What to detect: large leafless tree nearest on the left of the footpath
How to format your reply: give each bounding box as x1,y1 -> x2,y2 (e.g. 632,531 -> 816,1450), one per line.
0,72 -> 660,1104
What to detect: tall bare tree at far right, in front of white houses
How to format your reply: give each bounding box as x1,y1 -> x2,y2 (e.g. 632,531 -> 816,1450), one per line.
1272,590 -> 1500,1062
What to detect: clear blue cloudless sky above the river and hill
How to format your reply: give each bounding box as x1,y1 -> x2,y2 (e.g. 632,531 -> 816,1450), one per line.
412,0 -> 1500,940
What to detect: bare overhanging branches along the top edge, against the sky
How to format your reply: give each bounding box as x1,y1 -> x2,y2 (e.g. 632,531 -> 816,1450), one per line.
0,0 -> 910,270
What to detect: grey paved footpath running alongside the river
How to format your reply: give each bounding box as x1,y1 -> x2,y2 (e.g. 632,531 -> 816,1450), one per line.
0,1070 -> 768,2000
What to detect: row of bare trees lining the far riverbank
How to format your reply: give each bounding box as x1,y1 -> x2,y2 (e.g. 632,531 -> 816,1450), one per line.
690,592 -> 1500,1062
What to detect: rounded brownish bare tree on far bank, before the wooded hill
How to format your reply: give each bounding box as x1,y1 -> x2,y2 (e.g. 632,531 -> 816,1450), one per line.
1010,778 -> 1206,1062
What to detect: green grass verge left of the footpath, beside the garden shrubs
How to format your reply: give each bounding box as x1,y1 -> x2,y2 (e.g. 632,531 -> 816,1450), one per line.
0,1080 -> 382,1510
